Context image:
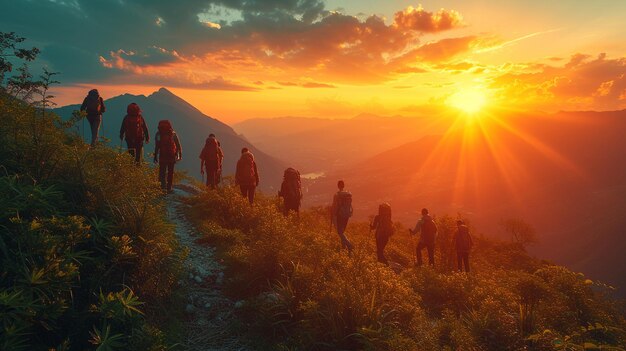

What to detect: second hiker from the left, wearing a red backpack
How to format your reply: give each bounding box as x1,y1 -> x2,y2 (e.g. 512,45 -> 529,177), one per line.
120,102 -> 150,164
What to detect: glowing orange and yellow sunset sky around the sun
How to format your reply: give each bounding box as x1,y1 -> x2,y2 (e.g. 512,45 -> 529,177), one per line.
39,0 -> 626,123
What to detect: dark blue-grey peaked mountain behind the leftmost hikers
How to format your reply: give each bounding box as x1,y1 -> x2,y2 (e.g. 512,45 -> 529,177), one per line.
54,88 -> 286,190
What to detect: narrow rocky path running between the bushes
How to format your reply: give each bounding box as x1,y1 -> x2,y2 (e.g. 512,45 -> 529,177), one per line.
167,186 -> 251,351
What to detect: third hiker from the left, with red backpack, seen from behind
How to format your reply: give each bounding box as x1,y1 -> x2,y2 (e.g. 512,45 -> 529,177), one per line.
154,119 -> 183,193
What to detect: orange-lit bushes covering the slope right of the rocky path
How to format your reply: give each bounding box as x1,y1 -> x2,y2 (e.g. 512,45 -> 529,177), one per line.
188,186 -> 626,350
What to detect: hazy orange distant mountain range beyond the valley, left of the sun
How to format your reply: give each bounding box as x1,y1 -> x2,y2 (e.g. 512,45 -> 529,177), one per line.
234,114 -> 450,172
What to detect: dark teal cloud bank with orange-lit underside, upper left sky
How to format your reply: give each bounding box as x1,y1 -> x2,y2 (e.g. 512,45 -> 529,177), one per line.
0,0 -> 469,88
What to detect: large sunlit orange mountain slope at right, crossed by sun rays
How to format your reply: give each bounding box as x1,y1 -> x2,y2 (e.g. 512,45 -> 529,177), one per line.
306,111 -> 626,294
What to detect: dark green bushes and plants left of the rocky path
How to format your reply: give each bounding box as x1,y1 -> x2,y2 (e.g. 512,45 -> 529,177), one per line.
0,33 -> 184,350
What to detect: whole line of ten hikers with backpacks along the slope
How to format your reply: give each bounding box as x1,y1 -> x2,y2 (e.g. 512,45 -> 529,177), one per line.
80,89 -> 473,272
